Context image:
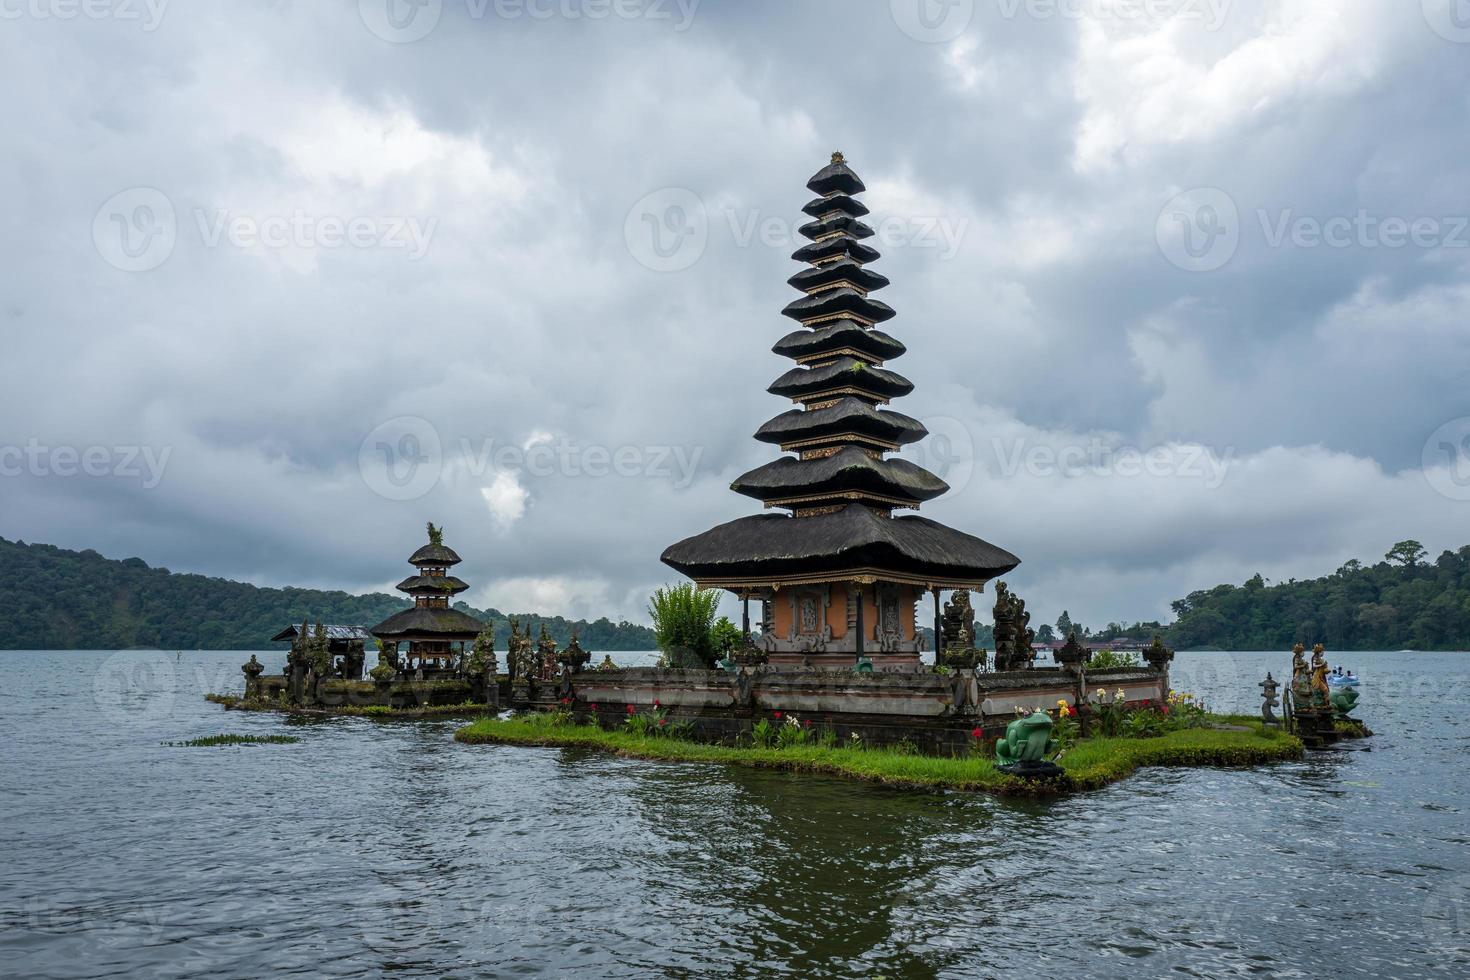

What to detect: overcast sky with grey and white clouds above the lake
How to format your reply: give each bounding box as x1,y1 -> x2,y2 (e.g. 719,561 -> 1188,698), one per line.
0,0 -> 1470,626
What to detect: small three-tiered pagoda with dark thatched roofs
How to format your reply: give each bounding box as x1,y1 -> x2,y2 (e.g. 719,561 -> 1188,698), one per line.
372,523 -> 485,676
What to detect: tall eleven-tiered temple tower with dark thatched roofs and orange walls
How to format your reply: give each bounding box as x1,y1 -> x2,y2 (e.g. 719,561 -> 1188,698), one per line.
663,153 -> 1020,670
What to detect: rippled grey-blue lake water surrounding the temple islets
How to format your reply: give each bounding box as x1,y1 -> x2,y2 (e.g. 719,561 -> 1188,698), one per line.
0,651 -> 1470,977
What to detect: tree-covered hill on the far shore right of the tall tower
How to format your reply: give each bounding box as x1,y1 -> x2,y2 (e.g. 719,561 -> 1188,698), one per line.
1169,541 -> 1470,649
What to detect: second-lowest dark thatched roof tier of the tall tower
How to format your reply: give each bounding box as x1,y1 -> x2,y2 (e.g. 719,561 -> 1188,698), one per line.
731,445 -> 950,504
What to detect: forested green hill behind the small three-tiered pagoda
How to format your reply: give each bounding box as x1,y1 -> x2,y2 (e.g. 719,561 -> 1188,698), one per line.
0,538 -> 654,652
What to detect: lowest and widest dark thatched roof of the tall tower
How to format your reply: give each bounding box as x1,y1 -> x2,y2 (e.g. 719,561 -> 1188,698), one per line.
663,504 -> 1020,583
